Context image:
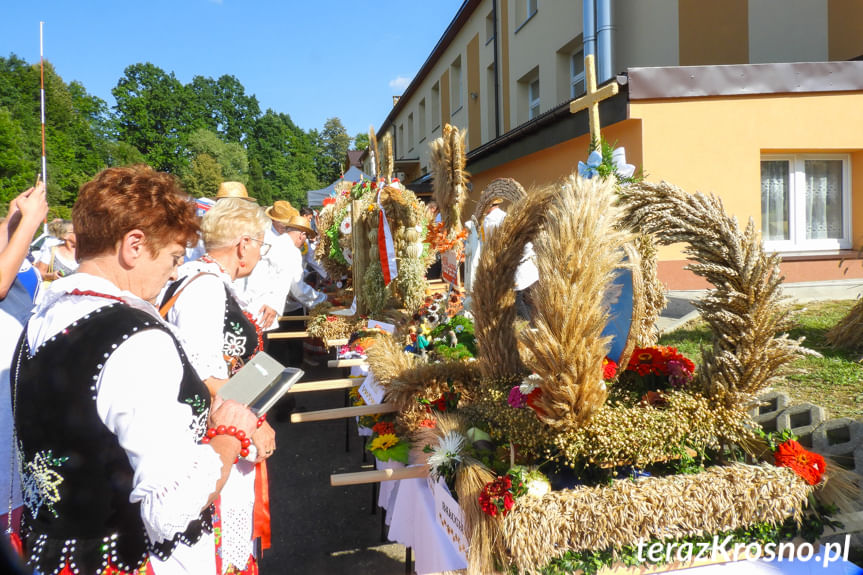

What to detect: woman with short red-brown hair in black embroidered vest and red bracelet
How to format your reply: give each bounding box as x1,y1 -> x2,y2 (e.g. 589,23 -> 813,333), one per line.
11,166 -> 256,575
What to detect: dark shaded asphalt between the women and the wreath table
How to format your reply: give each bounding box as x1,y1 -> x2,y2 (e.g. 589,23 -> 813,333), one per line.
260,340 -> 405,575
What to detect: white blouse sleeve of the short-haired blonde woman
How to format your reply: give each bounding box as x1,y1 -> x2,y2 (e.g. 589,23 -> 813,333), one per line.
168,275 -> 229,379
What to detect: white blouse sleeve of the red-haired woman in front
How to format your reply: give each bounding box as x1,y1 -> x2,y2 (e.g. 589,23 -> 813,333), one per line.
96,330 -> 221,541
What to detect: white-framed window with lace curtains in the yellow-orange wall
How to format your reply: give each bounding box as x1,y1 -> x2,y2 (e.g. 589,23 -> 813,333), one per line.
761,154 -> 851,251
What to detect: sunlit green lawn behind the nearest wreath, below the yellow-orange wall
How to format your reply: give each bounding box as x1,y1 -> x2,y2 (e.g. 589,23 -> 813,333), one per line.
659,300 -> 863,419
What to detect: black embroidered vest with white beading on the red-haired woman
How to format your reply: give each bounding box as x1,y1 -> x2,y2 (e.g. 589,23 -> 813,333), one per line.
11,303 -> 212,573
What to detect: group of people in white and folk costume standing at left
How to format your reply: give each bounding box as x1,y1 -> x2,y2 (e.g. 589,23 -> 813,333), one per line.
0,166 -> 326,575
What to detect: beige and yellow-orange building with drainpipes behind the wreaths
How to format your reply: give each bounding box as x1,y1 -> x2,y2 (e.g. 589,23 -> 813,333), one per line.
363,0 -> 863,289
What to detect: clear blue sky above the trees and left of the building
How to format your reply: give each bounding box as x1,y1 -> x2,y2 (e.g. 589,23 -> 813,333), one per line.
0,0 -> 463,141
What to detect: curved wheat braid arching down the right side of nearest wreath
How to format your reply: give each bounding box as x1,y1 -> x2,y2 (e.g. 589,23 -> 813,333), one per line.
620,181 -> 811,412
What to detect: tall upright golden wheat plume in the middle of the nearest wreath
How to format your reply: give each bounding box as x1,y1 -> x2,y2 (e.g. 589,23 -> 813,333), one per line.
520,175 -> 638,429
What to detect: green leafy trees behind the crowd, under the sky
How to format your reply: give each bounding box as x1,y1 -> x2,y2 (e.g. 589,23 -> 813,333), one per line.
0,54 -> 360,217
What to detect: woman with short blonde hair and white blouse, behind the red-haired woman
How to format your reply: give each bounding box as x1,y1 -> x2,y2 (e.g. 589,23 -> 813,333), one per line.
162,198 -> 275,573
